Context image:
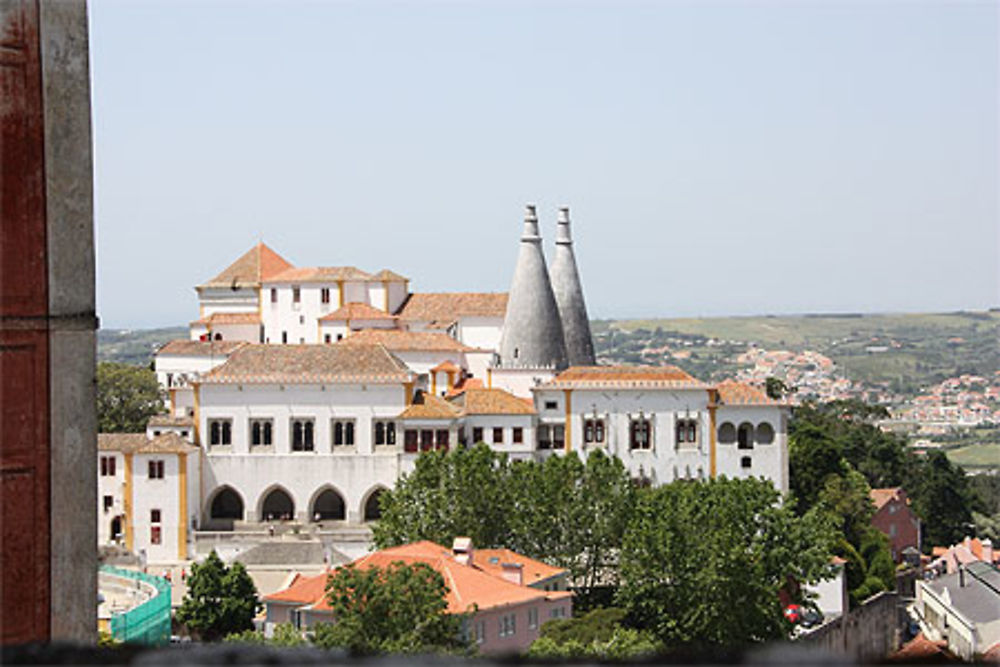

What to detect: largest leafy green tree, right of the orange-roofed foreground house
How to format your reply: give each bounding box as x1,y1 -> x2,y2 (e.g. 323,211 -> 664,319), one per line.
616,478 -> 836,649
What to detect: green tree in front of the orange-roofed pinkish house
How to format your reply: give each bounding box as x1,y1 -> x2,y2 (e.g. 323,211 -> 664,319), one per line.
313,562 -> 469,655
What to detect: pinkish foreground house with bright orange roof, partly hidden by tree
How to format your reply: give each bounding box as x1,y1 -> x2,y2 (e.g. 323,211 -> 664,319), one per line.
264,538 -> 573,655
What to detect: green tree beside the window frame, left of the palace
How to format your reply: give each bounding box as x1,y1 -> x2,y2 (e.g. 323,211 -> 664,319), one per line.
97,361 -> 163,433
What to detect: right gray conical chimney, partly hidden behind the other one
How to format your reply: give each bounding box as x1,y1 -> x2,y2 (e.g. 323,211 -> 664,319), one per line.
549,207 -> 597,366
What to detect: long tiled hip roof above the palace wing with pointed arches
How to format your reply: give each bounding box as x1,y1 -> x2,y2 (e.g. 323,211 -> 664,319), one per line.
201,344 -> 413,384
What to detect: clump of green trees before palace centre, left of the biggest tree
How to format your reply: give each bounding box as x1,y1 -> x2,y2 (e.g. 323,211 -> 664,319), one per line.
374,445 -> 635,607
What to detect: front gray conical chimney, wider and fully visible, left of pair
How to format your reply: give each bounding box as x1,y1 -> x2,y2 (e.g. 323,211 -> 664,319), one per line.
500,205 -> 566,370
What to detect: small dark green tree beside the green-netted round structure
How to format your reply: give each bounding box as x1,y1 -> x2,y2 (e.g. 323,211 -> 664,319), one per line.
177,550 -> 261,641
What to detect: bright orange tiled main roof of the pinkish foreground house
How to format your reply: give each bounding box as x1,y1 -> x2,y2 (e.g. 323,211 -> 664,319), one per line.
264,540 -> 572,614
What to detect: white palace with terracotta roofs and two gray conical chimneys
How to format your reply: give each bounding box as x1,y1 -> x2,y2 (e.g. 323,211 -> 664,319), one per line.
98,206 -> 788,562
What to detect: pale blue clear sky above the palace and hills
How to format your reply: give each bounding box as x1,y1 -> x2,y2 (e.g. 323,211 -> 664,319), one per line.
90,0 -> 1000,328
